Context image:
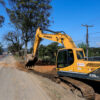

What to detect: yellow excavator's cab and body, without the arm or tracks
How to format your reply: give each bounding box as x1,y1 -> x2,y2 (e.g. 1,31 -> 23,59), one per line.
57,48 -> 100,81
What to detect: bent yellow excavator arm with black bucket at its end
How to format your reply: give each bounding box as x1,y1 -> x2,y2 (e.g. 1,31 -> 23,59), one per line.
26,27 -> 76,66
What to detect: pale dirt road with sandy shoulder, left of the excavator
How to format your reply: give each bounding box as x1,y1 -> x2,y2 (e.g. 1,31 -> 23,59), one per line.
0,56 -> 84,100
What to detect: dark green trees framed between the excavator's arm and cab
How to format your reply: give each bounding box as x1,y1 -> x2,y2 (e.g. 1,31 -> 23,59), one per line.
38,42 -> 62,64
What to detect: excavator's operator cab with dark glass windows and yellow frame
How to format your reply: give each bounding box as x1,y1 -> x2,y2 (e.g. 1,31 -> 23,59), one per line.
57,48 -> 85,68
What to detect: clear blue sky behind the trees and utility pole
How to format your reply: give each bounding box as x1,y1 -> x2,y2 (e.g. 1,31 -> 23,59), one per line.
0,0 -> 100,47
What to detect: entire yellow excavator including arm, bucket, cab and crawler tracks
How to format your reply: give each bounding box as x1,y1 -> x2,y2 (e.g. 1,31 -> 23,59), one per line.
26,27 -> 100,100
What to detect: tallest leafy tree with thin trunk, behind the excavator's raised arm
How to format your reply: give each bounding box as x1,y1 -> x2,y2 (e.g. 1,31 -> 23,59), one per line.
7,0 -> 51,56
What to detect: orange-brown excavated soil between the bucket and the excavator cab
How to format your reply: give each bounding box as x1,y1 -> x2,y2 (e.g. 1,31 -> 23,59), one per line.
17,60 -> 100,100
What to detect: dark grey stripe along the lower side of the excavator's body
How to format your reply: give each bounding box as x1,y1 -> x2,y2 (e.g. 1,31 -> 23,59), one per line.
57,71 -> 100,81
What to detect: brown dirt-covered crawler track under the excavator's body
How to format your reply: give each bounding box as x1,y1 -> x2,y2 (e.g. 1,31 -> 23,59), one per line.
59,77 -> 95,100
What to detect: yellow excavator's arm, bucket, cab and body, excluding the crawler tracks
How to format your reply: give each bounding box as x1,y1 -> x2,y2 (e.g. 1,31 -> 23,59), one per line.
26,27 -> 100,81
